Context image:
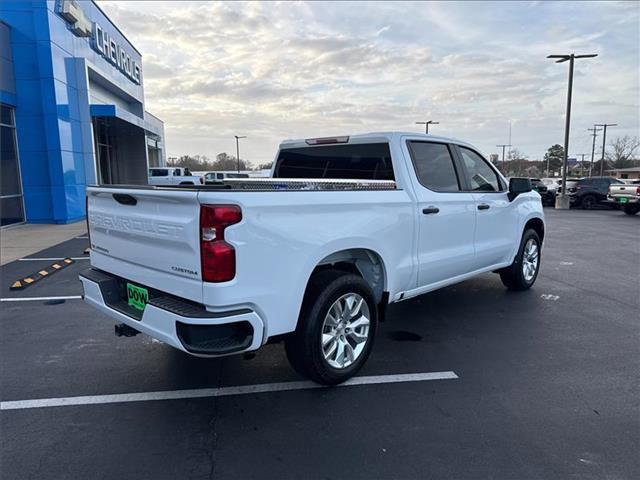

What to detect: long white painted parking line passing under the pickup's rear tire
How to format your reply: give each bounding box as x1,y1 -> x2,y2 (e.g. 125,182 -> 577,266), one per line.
0,371 -> 458,410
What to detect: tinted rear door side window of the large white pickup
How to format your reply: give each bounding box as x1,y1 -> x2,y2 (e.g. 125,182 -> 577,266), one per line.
408,141 -> 460,192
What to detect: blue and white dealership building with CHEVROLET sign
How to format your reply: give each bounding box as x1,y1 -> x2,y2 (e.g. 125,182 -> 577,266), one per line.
0,0 -> 165,226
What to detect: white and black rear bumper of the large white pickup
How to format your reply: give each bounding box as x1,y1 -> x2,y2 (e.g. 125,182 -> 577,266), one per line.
80,269 -> 265,357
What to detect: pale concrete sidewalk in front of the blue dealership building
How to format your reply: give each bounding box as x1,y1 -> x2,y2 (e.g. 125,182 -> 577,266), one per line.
0,222 -> 87,265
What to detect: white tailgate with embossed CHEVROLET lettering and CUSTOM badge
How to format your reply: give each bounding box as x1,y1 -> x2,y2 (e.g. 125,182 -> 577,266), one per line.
87,187 -> 202,302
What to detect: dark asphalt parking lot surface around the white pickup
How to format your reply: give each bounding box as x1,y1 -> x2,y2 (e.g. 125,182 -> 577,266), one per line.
0,209 -> 640,480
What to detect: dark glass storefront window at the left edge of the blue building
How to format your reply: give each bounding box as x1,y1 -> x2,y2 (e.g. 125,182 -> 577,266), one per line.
0,104 -> 24,227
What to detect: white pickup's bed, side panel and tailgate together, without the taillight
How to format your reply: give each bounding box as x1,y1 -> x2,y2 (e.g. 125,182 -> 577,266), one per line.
87,179 -> 415,335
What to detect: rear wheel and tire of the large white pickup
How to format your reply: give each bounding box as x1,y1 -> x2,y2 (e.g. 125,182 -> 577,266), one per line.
285,270 -> 378,385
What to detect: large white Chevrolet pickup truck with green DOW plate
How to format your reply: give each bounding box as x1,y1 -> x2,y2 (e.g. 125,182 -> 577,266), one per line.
80,133 -> 545,384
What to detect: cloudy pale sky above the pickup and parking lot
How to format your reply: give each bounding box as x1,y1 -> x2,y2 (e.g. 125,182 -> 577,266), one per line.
99,1 -> 640,164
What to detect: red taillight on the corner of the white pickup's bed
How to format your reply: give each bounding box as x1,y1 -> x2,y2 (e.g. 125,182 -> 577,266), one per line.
200,205 -> 242,282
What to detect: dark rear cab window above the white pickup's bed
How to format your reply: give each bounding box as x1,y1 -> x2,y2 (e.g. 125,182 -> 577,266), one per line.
273,143 -> 395,180
